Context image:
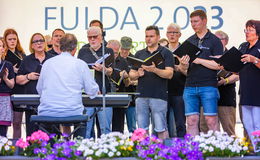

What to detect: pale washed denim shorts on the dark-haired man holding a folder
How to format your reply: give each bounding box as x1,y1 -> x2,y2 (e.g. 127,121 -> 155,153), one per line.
135,98 -> 167,132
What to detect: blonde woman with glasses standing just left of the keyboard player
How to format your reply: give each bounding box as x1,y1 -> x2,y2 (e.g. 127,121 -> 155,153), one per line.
16,33 -> 52,136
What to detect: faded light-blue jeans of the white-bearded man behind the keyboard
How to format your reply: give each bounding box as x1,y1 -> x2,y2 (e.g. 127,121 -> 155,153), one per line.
86,107 -> 113,138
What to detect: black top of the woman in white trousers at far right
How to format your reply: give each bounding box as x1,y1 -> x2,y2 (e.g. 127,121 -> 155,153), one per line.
239,40 -> 260,106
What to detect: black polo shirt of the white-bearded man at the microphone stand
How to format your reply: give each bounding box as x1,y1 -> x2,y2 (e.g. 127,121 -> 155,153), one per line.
78,45 -> 114,92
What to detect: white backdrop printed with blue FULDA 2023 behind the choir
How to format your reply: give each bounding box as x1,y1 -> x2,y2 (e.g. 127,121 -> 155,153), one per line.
0,0 -> 260,53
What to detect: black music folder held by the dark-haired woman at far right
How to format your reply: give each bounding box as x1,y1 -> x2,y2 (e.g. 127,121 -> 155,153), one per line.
214,47 -> 245,72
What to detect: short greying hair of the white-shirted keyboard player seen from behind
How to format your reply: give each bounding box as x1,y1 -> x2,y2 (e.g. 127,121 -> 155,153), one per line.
60,33 -> 78,52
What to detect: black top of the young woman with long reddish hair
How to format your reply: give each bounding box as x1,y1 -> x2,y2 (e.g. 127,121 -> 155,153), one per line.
5,50 -> 26,94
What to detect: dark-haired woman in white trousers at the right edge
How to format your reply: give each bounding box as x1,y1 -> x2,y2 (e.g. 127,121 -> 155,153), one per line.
239,20 -> 260,151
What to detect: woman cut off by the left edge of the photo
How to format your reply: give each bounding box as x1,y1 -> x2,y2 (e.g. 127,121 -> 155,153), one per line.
0,38 -> 15,137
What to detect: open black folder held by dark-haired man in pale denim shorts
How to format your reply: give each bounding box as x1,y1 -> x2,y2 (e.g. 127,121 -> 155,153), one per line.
127,51 -> 164,68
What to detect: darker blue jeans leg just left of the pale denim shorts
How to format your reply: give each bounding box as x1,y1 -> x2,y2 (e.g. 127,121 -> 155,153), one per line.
125,106 -> 136,133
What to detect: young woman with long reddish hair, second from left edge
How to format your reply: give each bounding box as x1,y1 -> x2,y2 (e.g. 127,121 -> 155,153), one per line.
4,29 -> 26,139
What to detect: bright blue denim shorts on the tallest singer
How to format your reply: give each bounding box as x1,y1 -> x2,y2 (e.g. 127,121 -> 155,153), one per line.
183,87 -> 219,116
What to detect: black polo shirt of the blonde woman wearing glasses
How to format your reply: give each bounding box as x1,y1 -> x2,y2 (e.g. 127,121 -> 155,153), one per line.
17,53 -> 53,94
